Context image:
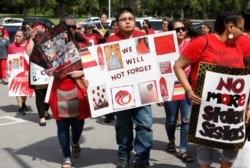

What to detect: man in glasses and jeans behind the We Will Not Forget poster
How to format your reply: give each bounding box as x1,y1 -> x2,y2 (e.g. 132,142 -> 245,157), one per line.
107,8 -> 153,168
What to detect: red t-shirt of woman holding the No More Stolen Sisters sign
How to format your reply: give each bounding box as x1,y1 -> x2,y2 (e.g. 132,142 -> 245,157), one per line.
182,33 -> 244,89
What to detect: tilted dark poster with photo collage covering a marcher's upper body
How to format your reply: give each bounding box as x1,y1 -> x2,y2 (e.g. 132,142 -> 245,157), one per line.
31,22 -> 82,80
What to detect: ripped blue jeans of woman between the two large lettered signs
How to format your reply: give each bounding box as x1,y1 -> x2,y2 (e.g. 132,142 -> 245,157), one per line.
164,100 -> 191,153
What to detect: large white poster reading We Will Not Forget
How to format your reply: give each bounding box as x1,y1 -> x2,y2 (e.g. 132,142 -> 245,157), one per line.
83,31 -> 185,117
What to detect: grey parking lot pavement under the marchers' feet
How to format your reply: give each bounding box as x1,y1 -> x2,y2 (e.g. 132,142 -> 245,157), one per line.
0,85 -> 219,168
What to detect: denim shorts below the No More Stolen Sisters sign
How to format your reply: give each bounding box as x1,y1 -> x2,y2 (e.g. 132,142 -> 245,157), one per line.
197,146 -> 239,165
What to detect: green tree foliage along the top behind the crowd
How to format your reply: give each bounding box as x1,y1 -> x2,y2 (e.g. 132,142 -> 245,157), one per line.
0,0 -> 249,19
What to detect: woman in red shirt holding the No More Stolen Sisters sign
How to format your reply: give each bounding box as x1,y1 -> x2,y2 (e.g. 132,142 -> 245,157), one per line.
174,12 -> 247,168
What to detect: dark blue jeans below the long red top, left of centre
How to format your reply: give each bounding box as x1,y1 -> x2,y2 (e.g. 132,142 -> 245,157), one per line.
56,118 -> 84,158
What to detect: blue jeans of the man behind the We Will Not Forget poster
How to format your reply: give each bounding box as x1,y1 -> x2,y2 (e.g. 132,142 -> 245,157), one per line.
115,106 -> 153,163
